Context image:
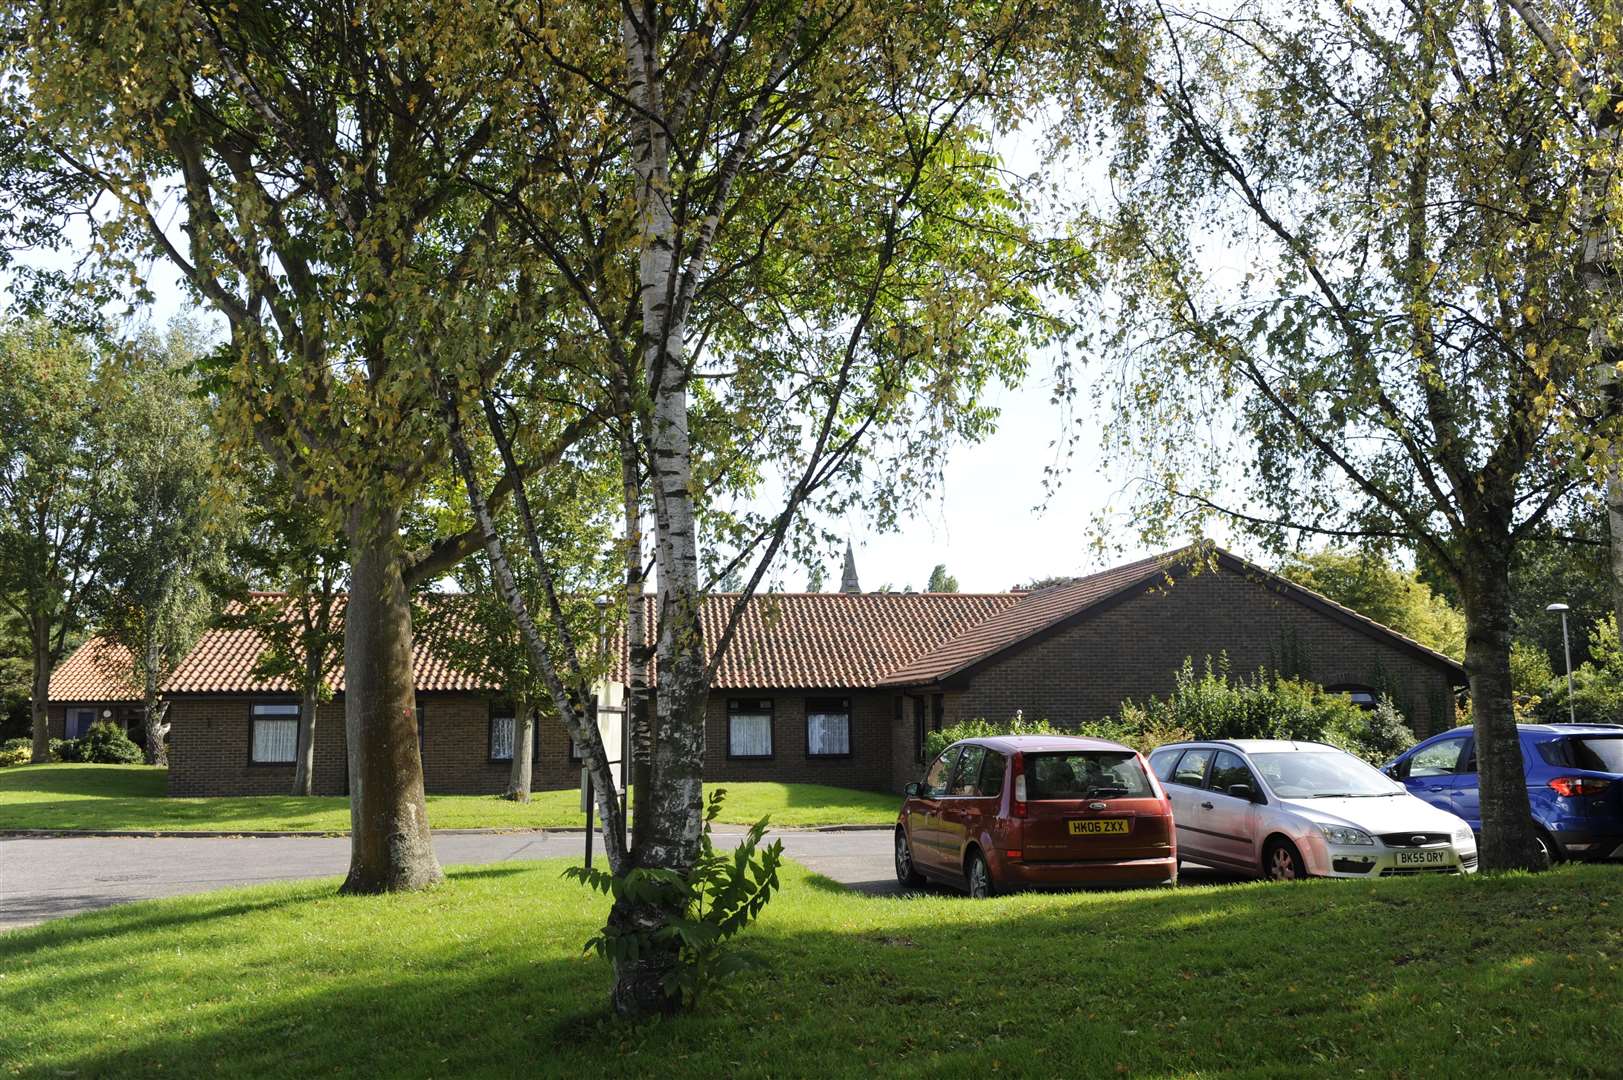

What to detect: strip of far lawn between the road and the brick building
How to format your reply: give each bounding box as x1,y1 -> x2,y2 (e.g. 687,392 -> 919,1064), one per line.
0,765 -> 901,833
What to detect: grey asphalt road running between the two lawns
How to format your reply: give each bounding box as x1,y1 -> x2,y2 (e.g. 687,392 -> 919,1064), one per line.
0,830 -> 1233,931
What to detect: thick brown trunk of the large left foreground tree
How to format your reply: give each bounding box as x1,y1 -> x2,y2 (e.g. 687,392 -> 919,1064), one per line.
342,503 -> 445,893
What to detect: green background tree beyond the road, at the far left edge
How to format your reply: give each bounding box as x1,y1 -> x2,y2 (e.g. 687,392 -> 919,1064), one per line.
0,320 -> 114,762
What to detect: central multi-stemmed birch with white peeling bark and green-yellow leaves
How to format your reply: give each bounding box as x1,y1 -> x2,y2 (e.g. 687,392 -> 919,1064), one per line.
432,0 -> 1121,1015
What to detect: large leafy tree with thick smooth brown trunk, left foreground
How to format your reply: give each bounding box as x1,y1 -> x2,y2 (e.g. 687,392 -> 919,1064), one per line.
0,0 -> 577,892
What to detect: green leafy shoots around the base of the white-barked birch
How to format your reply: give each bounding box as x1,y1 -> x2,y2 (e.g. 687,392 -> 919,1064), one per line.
563,788 -> 784,1005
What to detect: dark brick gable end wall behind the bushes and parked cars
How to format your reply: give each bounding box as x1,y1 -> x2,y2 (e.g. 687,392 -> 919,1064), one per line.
948,570 -> 1453,737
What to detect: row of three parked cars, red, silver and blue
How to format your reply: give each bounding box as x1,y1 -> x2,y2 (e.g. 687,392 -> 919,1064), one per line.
896,724 -> 1623,896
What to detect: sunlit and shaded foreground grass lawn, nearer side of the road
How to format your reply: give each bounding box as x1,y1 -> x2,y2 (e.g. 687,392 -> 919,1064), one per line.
0,862 -> 1623,1077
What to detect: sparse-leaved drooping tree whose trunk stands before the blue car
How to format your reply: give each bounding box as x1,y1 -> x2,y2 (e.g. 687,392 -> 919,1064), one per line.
1097,2 -> 1617,869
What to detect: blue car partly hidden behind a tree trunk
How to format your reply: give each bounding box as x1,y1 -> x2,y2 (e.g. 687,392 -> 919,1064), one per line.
1381,724 -> 1623,861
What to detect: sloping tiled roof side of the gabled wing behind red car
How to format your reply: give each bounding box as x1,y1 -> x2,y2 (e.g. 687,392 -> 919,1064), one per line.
880,552 -> 1178,685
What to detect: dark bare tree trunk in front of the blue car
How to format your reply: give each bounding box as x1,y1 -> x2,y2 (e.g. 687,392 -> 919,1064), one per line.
1461,544 -> 1543,870
